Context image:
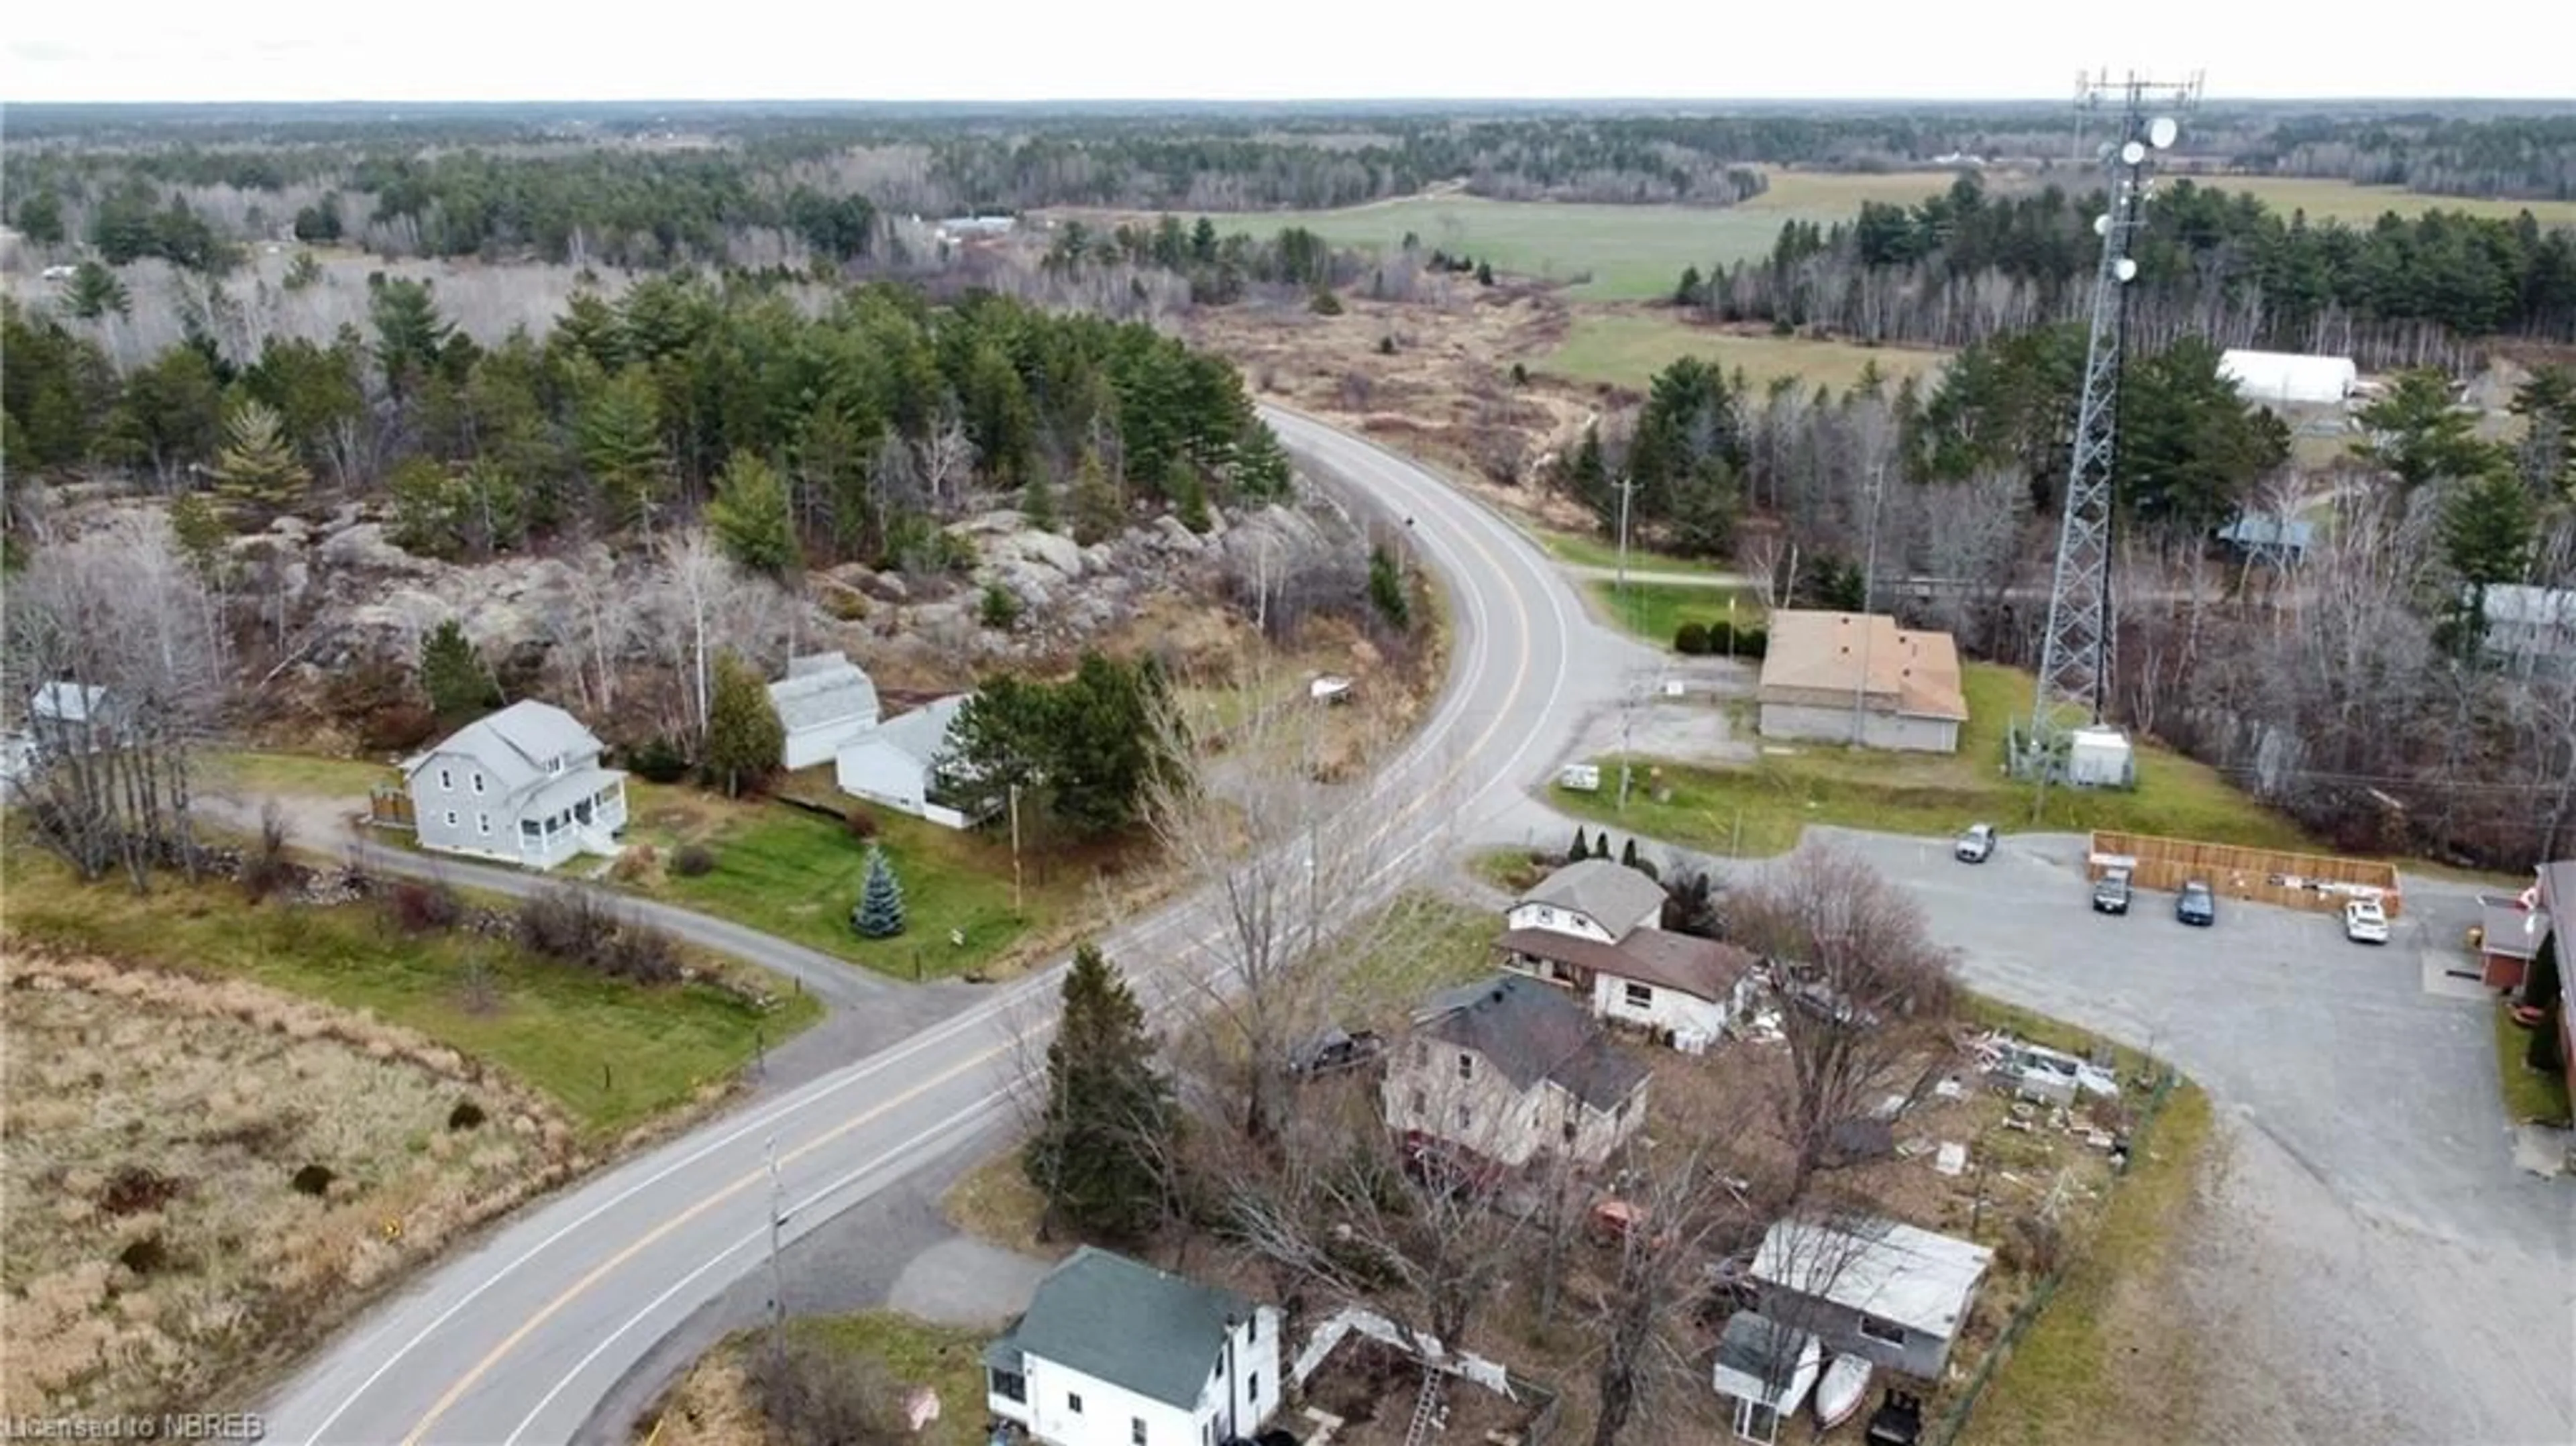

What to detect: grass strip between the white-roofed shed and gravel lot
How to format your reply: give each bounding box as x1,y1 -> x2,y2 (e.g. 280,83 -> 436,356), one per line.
1927,1085 -> 2210,1446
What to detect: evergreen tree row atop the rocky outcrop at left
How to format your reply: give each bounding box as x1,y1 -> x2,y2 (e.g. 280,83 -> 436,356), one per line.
0,278 -> 1288,572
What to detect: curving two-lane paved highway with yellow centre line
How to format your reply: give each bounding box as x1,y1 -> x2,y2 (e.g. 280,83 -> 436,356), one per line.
266,399 -> 1654,1446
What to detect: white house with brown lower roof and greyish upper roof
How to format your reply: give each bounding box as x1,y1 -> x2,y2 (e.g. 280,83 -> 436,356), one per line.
1494,858 -> 1754,1054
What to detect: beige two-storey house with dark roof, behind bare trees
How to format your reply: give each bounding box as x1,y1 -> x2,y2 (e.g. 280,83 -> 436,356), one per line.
1381,975 -> 1651,1170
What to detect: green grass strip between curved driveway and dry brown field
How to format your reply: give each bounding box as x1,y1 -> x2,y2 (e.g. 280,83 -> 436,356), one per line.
8,848 -> 819,1137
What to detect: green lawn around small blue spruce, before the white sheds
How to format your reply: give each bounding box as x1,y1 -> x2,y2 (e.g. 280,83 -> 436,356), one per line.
626,779 -> 1118,979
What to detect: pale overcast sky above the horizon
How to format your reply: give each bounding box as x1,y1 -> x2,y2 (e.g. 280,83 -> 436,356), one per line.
0,0 -> 2576,101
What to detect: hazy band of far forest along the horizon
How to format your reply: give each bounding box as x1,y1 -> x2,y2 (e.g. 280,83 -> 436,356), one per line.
0,106 -> 2576,266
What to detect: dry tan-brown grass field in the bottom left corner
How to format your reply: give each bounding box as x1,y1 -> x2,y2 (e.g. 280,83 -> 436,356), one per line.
0,951 -> 582,1415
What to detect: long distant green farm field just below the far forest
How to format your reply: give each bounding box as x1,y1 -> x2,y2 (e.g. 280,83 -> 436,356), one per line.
1185,170 -> 2576,302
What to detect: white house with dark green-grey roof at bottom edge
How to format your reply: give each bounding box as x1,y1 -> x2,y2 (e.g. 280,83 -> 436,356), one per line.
984,1245 -> 1283,1446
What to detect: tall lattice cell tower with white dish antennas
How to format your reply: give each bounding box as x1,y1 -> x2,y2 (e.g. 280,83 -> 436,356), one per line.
2030,72 -> 2200,768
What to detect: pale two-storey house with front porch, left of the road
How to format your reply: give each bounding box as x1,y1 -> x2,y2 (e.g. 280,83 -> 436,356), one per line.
402,701 -> 626,869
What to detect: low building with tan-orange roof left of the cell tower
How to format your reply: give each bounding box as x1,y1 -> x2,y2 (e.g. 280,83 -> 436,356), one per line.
1754,608 -> 1968,753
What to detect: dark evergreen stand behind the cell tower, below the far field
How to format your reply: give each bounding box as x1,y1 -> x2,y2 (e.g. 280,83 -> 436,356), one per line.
1677,178 -> 2576,366
